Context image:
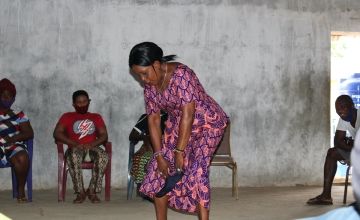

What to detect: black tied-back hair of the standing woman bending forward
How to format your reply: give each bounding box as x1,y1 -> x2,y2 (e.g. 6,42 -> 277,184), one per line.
129,42 -> 176,68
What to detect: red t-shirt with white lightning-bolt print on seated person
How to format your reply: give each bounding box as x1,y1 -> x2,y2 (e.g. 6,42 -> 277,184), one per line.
58,112 -> 105,144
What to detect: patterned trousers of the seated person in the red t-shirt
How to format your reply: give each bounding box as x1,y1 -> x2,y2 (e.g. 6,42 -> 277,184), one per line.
65,147 -> 109,193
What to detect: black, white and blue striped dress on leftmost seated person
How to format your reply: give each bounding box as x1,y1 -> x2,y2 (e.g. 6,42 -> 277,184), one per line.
0,110 -> 29,165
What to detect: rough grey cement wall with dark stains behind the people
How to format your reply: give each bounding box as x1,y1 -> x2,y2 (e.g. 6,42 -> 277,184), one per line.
0,0 -> 360,189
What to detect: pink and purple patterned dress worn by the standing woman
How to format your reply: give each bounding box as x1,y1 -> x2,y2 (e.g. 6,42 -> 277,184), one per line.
140,64 -> 228,212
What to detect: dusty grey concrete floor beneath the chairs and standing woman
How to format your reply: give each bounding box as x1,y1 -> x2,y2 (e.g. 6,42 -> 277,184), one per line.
0,186 -> 354,220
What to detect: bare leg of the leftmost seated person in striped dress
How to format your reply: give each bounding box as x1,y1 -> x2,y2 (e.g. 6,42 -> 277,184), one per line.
10,150 -> 29,198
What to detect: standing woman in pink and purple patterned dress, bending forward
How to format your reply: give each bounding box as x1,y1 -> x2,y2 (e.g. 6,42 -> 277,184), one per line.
129,42 -> 228,220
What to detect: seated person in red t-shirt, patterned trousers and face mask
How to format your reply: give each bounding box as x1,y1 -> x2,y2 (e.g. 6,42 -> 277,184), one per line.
54,90 -> 109,203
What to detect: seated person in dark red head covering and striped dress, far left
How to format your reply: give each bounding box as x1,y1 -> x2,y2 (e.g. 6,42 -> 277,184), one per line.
0,78 -> 34,203
